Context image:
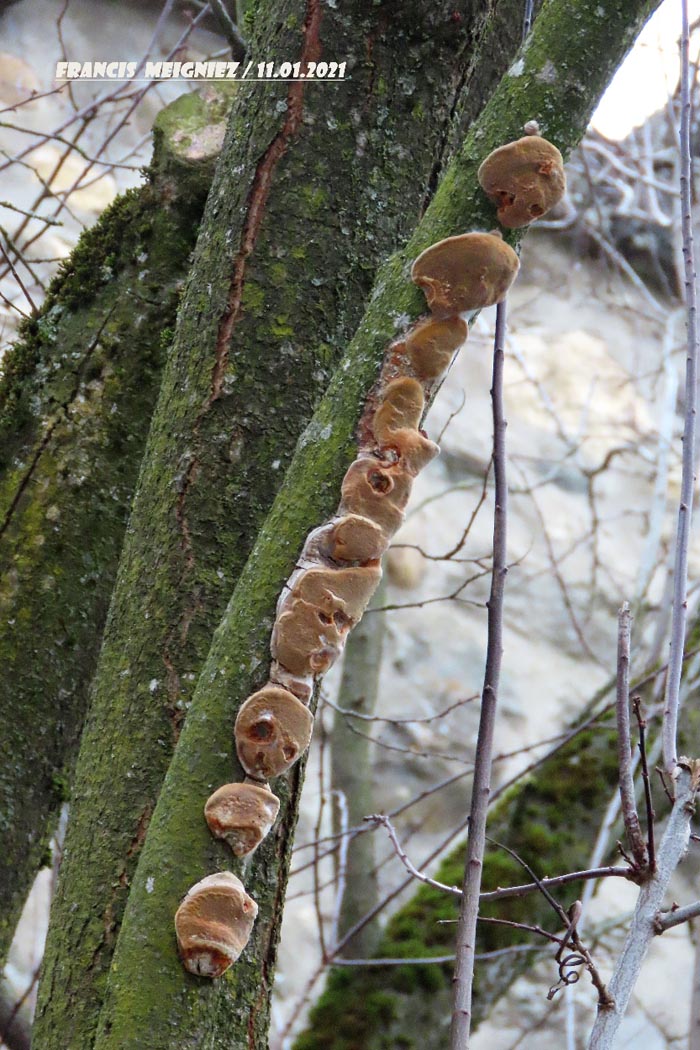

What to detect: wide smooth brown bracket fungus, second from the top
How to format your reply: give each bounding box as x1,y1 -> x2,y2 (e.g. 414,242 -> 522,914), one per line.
410,233 -> 519,318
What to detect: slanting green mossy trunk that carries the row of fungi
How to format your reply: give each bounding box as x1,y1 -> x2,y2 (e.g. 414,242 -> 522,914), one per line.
67,0 -> 653,1050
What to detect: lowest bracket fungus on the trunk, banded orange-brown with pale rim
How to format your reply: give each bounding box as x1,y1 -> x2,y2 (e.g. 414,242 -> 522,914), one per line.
175,872 -> 257,978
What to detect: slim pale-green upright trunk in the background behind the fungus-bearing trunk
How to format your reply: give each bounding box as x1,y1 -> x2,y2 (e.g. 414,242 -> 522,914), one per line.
331,585 -> 386,959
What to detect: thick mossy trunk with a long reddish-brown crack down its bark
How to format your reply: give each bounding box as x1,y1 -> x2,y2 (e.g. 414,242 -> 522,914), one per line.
34,0 -> 514,1050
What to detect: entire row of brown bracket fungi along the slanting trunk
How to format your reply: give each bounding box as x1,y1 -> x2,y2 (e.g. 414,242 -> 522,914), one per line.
175,124 -> 565,978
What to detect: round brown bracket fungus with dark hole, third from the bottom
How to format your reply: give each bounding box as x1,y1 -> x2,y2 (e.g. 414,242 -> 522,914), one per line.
234,686 -> 314,780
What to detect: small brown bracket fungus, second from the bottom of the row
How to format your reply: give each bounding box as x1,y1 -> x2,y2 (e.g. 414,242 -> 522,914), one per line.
205,781 -> 279,857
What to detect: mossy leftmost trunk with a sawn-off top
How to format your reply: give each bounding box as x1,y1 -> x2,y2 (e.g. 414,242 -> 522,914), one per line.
0,86 -> 228,960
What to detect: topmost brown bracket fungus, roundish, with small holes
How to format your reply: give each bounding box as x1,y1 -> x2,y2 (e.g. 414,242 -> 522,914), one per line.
479,134 -> 567,229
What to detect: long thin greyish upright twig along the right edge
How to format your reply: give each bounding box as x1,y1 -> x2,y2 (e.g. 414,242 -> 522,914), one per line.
662,0 -> 698,773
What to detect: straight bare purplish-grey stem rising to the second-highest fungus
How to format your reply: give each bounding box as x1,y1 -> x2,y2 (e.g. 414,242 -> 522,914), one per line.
450,301 -> 508,1050
